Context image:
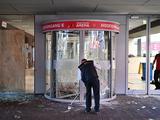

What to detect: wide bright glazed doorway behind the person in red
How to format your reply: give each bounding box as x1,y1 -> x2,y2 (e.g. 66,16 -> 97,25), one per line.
126,16 -> 160,94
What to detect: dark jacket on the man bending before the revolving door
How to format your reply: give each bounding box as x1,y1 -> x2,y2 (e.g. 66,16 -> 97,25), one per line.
78,60 -> 98,83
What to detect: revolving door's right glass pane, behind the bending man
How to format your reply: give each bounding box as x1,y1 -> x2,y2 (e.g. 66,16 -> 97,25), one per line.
84,31 -> 112,98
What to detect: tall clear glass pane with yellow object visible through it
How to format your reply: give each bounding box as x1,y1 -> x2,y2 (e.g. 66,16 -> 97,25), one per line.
128,18 -> 147,90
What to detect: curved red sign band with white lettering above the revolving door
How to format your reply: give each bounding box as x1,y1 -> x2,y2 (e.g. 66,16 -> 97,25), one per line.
42,20 -> 120,32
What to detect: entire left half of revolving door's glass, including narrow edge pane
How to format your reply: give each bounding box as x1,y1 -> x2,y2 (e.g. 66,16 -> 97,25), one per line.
46,31 -> 79,99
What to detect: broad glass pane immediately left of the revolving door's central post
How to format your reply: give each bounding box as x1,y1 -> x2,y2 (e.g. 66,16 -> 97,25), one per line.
56,31 -> 79,98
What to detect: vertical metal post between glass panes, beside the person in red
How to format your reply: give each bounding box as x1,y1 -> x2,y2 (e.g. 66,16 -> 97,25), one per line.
146,17 -> 151,95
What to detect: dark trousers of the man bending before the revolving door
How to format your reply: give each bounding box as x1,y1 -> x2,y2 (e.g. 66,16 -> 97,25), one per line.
85,78 -> 100,110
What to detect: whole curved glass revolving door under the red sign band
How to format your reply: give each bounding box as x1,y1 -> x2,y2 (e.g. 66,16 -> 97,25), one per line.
42,19 -> 119,101
